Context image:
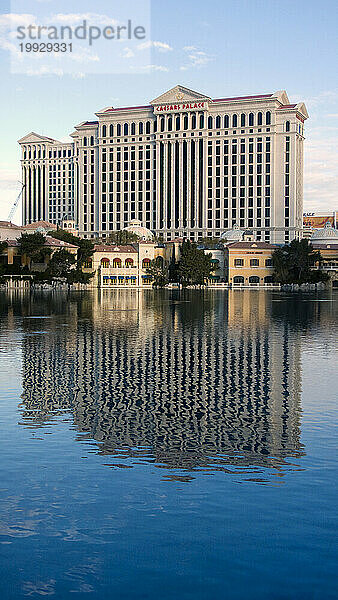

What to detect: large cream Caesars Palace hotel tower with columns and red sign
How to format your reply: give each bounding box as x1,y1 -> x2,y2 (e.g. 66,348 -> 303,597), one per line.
19,86 -> 308,243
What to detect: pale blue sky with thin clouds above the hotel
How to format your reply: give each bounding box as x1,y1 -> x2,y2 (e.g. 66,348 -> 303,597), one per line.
0,0 -> 338,222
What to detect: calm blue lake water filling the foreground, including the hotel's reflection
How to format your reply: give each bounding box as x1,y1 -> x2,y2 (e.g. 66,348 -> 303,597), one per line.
0,290 -> 338,600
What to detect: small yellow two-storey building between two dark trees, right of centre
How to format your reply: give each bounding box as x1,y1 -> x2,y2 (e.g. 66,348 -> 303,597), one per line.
225,242 -> 276,286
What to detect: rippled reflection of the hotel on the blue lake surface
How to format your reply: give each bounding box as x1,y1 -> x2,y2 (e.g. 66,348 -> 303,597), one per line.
10,290 -> 312,481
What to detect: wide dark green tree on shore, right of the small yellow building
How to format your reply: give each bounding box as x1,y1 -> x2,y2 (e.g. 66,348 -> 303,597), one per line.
272,239 -> 327,283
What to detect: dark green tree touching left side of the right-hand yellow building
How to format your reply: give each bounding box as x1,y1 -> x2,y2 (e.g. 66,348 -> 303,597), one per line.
178,240 -> 212,287
